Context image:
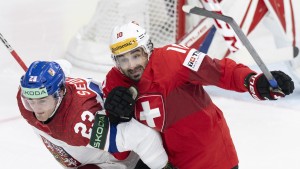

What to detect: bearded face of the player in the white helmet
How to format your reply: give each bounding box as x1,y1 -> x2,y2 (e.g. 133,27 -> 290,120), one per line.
116,47 -> 148,81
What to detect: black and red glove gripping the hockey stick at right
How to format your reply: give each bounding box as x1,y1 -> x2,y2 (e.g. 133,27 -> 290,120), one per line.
245,71 -> 295,100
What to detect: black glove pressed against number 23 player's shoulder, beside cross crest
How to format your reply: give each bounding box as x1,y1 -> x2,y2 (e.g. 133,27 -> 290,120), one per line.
104,87 -> 138,124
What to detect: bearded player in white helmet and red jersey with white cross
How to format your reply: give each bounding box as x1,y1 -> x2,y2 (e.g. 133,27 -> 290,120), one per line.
103,22 -> 294,169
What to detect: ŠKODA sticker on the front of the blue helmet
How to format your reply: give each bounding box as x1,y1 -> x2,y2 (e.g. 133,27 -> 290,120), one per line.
21,87 -> 48,99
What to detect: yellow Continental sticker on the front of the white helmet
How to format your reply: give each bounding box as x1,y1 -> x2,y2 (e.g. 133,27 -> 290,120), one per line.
110,38 -> 138,55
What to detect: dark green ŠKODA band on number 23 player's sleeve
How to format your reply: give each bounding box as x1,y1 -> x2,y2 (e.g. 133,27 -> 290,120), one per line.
90,114 -> 109,150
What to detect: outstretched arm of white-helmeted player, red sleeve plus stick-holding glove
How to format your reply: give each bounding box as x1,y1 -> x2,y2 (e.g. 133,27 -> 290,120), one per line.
166,45 -> 294,100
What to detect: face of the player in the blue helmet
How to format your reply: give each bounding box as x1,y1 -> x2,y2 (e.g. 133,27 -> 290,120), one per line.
26,95 -> 58,121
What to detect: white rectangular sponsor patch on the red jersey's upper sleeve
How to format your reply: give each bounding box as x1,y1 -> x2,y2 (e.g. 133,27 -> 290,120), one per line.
183,49 -> 205,71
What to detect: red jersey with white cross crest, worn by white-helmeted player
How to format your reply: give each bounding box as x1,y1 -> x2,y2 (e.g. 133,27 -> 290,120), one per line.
103,44 -> 253,169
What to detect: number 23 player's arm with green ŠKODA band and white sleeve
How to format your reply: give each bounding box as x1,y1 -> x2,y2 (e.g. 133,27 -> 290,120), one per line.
90,111 -> 172,168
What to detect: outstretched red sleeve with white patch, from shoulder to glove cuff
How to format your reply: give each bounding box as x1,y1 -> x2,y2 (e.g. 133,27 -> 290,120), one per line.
164,45 -> 255,92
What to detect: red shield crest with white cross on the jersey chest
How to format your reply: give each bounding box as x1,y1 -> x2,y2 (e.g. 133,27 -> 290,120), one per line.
135,95 -> 165,131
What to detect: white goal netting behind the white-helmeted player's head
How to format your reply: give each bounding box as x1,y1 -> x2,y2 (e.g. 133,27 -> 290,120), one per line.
66,0 -> 182,71
